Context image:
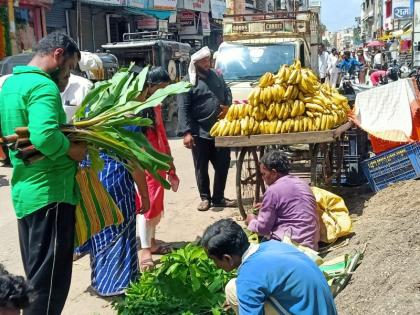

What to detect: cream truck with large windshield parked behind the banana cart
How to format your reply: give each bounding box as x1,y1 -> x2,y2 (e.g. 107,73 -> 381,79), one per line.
216,11 -> 321,100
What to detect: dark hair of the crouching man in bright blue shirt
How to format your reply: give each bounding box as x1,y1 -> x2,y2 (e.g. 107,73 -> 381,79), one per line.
201,219 -> 249,259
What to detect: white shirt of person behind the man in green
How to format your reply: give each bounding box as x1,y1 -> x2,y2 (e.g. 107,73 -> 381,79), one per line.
61,74 -> 93,122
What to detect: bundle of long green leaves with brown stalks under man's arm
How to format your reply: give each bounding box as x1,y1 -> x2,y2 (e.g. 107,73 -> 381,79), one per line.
0,65 -> 190,188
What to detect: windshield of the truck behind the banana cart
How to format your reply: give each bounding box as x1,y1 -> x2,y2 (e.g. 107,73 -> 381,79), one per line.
216,43 -> 296,81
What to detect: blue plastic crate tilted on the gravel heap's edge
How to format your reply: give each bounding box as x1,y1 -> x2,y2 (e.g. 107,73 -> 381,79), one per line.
361,143 -> 420,191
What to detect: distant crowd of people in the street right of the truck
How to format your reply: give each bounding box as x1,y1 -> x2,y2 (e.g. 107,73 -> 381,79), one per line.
318,44 -> 395,87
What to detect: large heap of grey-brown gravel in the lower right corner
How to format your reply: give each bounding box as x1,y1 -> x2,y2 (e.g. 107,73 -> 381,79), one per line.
328,181 -> 420,315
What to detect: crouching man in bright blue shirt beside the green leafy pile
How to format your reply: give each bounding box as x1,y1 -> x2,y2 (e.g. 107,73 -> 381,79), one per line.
201,219 -> 337,315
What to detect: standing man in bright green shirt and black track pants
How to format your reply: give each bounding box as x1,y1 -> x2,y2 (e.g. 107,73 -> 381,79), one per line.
0,33 -> 86,315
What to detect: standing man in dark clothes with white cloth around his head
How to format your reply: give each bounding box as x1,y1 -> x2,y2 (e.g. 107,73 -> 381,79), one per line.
178,47 -> 236,211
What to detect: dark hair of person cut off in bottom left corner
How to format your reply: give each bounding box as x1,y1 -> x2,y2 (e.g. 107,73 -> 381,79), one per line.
0,264 -> 32,309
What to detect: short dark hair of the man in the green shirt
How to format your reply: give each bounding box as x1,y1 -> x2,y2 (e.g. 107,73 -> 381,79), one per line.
34,32 -> 80,59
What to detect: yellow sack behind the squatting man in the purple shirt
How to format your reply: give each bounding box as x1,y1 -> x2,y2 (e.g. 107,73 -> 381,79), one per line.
311,187 -> 352,243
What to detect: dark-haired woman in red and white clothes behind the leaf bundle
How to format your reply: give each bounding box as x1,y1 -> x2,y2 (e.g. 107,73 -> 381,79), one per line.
136,67 -> 179,271
